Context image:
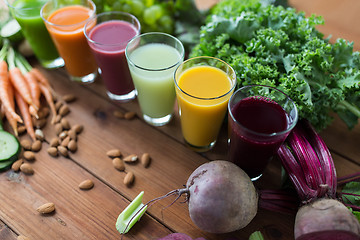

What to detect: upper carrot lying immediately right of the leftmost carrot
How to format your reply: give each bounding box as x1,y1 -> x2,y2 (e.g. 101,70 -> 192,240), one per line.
9,67 -> 38,110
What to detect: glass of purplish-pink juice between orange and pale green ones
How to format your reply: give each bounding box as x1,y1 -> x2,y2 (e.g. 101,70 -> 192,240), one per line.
84,12 -> 141,102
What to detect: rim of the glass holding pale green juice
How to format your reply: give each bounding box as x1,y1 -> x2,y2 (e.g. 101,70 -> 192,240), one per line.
125,32 -> 185,72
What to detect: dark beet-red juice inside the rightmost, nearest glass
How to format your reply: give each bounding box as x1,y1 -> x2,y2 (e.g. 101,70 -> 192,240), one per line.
229,97 -> 289,178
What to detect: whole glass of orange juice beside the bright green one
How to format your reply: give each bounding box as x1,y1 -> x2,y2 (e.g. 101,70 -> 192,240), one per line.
40,0 -> 98,83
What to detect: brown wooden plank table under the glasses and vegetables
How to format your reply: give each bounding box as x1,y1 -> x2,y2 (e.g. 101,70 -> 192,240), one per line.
0,0 -> 360,240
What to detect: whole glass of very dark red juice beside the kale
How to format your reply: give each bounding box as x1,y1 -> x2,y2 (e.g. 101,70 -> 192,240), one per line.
228,85 -> 298,181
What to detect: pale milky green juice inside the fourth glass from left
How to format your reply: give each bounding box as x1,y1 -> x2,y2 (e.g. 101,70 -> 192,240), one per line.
129,43 -> 182,118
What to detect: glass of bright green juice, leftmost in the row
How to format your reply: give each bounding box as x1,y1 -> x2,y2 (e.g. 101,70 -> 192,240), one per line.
6,0 -> 64,68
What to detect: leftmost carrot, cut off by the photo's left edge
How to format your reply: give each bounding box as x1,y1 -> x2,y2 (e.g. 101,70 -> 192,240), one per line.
0,60 -> 23,123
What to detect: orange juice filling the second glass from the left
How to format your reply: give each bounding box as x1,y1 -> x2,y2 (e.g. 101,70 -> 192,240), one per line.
47,5 -> 97,77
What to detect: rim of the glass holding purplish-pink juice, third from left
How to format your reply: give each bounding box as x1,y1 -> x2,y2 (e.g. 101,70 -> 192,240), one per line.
84,11 -> 141,46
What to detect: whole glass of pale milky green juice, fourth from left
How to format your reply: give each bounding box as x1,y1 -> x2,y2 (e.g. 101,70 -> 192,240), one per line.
125,32 -> 185,126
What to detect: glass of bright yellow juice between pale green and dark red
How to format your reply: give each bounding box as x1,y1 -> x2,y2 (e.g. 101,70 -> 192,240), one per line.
174,56 -> 236,152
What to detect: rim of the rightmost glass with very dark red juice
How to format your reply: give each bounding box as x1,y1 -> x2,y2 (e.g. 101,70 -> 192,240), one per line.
228,84 -> 299,137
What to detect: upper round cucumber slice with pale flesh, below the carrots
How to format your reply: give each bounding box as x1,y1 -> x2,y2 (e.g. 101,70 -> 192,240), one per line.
0,131 -> 21,162
